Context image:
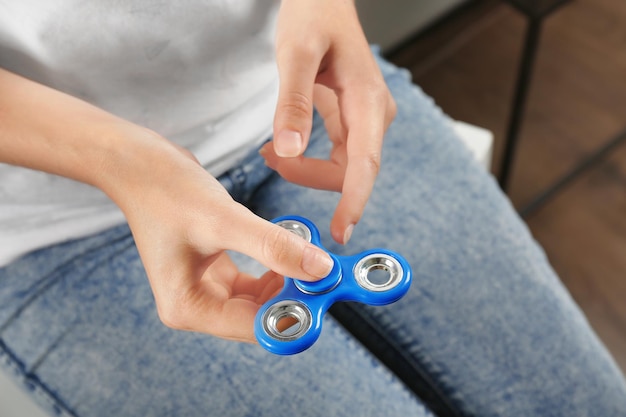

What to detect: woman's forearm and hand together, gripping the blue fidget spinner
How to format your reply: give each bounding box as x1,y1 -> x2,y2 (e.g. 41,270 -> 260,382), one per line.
0,69 -> 332,342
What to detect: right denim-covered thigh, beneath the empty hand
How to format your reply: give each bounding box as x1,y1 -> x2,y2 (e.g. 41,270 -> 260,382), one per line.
247,56 -> 626,415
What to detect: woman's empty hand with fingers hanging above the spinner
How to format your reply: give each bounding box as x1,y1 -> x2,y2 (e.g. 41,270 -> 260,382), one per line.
261,0 -> 396,243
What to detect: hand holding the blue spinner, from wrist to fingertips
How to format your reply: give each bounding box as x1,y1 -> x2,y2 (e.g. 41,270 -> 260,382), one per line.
104,138 -> 333,342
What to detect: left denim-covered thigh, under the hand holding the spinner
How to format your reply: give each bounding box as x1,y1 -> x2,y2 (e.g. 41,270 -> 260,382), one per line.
0,227 -> 431,416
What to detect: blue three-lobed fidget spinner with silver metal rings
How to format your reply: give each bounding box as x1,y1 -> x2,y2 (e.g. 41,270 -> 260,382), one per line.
254,216 -> 411,355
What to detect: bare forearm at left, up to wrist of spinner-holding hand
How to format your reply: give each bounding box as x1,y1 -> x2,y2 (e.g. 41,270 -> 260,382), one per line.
0,69 -> 172,203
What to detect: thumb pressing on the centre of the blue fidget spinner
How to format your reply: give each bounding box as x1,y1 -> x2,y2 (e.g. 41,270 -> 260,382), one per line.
226,207 -> 334,281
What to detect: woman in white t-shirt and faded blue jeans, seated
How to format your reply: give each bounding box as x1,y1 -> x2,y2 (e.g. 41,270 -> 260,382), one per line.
0,0 -> 626,416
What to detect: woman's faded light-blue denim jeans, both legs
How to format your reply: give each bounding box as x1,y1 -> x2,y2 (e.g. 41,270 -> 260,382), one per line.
0,53 -> 626,417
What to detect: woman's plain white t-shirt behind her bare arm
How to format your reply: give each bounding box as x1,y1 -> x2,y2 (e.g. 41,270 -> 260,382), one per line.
0,0 -> 278,266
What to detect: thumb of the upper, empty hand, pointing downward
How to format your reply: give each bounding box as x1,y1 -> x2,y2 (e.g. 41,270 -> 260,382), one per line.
274,46 -> 321,158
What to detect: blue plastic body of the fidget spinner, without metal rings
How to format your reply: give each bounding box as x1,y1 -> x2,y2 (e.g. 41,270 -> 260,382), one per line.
254,216 -> 412,355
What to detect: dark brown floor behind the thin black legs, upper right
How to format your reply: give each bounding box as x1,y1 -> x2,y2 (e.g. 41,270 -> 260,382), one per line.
389,0 -> 626,371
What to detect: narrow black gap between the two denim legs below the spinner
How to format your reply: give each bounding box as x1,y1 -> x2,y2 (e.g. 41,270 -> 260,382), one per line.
330,303 -> 466,417
